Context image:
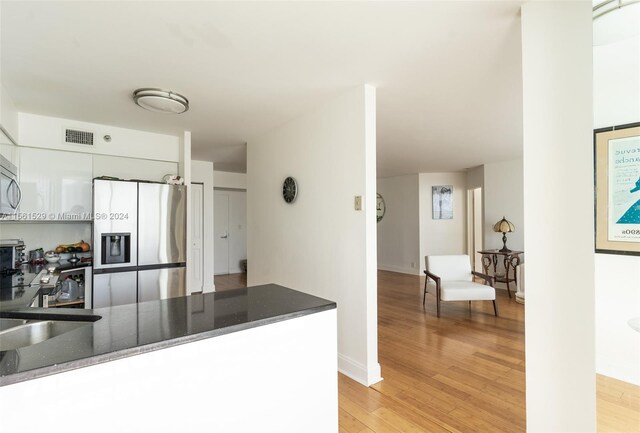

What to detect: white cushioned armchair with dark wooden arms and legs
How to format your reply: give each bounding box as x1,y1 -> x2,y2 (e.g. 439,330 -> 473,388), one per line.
422,255 -> 498,317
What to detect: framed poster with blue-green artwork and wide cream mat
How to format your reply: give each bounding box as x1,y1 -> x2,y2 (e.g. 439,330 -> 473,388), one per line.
593,123 -> 640,255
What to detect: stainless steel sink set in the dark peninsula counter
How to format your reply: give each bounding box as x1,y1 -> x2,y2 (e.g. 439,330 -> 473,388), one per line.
0,318 -> 90,351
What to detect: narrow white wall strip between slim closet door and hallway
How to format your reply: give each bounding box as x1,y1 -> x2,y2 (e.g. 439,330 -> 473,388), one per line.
191,160 -> 215,293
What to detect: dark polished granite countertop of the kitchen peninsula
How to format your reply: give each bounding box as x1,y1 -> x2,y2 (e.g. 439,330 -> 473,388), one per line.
0,284 -> 336,386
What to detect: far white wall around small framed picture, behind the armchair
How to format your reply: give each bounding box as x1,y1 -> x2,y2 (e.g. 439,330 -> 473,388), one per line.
419,172 -> 467,273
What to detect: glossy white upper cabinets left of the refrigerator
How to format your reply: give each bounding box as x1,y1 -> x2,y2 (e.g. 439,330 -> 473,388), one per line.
18,147 -> 93,221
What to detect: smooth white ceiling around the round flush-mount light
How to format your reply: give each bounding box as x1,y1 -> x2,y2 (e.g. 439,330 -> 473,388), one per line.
0,1 -> 522,177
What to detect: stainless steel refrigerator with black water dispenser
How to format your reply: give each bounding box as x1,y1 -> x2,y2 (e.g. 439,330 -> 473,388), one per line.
93,179 -> 186,308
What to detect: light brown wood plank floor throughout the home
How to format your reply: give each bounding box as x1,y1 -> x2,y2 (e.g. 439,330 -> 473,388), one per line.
215,271 -> 640,433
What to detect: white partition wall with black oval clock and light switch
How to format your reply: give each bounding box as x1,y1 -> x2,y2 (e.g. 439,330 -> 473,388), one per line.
247,86 -> 380,385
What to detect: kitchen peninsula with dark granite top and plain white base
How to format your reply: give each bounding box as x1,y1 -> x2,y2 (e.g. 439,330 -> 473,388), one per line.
0,284 -> 338,432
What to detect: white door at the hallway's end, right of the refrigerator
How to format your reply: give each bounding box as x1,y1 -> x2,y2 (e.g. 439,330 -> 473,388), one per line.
213,189 -> 247,275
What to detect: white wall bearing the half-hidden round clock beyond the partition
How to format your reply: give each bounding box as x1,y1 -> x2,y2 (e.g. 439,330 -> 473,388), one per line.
377,174 -> 421,274
